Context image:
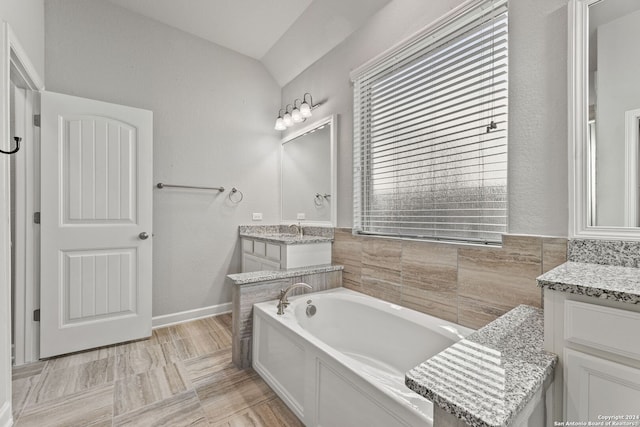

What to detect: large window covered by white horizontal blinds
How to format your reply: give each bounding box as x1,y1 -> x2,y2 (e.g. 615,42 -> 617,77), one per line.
352,0 -> 507,243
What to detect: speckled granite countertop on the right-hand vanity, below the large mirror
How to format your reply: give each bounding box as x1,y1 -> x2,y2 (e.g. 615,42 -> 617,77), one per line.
537,261 -> 640,304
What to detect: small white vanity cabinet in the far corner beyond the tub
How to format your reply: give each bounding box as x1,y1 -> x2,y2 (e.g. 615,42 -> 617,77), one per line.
241,237 -> 331,273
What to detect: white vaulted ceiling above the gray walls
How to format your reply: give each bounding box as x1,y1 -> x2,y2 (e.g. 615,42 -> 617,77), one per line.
108,0 -> 390,86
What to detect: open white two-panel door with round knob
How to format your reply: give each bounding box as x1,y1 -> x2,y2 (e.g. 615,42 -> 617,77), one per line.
40,92 -> 153,357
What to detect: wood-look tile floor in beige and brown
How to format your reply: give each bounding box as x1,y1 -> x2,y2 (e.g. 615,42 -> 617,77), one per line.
13,314 -> 302,427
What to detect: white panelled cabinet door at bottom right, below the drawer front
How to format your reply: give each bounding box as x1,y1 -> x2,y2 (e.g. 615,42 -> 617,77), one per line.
564,349 -> 640,421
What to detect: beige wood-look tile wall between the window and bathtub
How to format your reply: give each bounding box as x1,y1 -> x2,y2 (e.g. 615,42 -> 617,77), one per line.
333,228 -> 567,328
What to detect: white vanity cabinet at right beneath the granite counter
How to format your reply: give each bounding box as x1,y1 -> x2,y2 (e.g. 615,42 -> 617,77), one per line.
544,289 -> 640,425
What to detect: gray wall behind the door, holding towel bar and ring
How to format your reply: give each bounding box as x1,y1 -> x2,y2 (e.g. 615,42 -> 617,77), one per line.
46,0 -> 280,316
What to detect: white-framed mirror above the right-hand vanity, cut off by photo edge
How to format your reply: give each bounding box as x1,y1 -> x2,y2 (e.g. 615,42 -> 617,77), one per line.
569,0 -> 640,240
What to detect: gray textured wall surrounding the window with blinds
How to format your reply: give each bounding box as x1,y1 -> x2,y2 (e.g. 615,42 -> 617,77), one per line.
282,0 -> 568,236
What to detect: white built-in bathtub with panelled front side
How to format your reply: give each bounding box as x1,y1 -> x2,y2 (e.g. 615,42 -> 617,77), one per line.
253,288 -> 473,427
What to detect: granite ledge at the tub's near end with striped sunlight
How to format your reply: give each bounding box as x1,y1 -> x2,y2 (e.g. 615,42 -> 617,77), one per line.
405,305 -> 558,427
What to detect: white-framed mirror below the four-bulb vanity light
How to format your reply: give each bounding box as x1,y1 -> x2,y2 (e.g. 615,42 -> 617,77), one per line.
280,115 -> 337,227
